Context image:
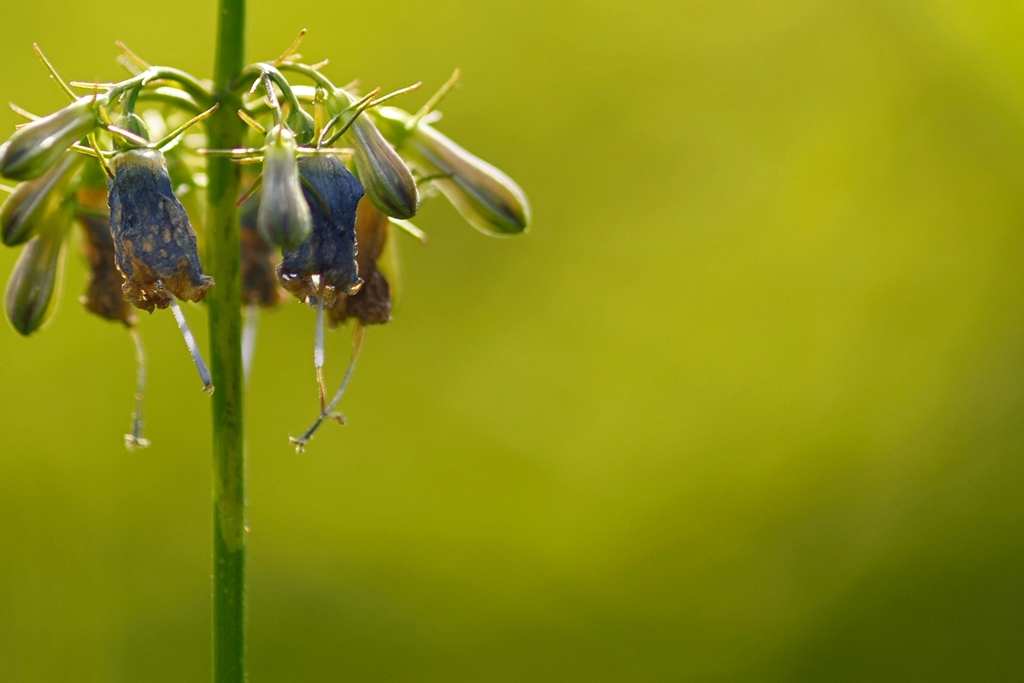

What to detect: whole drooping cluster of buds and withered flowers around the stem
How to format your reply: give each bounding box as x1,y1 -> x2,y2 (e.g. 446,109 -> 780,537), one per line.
0,36 -> 529,450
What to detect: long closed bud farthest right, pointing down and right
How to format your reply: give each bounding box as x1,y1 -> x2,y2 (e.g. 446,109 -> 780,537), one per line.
374,106 -> 529,234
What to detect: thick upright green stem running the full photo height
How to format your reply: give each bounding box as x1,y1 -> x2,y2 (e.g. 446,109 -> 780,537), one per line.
206,0 -> 248,683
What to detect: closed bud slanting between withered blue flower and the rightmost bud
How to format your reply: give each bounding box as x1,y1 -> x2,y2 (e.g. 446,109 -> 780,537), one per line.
327,90 -> 420,218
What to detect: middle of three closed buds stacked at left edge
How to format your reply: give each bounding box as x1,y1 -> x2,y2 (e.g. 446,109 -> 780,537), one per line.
0,152 -> 85,247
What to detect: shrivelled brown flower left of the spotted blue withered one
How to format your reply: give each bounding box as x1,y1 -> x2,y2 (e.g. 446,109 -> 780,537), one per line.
78,187 -> 135,327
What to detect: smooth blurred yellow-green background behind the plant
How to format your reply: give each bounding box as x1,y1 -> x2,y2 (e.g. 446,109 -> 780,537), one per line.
0,0 -> 1024,683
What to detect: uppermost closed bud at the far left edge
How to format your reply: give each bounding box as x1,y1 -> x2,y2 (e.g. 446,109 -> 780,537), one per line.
0,97 -> 100,180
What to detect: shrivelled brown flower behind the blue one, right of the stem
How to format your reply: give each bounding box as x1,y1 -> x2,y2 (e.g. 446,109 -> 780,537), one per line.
328,197 -> 391,327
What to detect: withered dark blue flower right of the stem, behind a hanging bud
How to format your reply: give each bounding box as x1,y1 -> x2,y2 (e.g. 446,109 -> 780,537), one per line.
278,155 -> 362,308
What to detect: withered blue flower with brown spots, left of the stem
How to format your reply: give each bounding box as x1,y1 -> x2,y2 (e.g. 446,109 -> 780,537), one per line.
108,148 -> 213,312
